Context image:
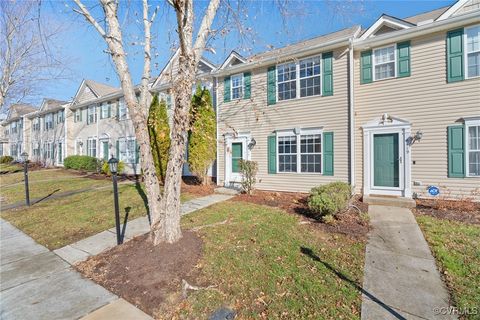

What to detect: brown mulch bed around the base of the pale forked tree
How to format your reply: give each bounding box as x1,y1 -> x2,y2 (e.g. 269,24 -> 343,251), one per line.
76,231 -> 202,317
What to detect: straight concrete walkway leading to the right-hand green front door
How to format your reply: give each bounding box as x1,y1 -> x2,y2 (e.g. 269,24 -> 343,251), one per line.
362,205 -> 456,320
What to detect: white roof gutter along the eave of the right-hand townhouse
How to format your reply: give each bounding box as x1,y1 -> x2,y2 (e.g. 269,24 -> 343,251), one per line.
353,10 -> 480,50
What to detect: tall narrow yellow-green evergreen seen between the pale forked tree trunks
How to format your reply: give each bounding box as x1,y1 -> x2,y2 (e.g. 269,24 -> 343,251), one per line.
147,94 -> 170,182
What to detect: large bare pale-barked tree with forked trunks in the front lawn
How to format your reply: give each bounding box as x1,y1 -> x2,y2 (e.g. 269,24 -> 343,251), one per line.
73,0 -> 220,244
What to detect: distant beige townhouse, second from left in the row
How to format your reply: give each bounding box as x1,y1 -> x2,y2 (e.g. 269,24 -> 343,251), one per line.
25,99 -> 69,166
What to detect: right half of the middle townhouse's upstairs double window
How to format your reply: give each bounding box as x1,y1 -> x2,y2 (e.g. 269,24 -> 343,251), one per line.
299,56 -> 321,97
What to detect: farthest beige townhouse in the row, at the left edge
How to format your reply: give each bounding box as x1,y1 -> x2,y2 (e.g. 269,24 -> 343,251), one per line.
1,104 -> 37,160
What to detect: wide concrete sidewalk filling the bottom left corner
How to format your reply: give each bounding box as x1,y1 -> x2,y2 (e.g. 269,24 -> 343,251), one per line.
0,219 -> 151,320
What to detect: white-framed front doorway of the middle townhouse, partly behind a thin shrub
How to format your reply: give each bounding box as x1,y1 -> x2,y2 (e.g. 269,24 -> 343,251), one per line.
224,134 -> 250,187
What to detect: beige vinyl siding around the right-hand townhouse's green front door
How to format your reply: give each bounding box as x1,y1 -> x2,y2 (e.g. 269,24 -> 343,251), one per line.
355,27 -> 480,200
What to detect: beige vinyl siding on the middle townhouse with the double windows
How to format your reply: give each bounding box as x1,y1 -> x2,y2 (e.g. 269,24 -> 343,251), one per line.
217,48 -> 348,192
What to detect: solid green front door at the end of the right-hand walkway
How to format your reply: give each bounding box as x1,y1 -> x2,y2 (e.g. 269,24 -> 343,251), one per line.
373,133 -> 400,188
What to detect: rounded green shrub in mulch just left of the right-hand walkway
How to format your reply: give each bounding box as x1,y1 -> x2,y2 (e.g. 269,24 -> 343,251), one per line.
308,181 -> 352,217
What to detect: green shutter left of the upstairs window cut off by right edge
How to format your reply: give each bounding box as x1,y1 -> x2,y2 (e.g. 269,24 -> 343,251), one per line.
447,29 -> 464,82
